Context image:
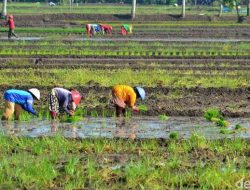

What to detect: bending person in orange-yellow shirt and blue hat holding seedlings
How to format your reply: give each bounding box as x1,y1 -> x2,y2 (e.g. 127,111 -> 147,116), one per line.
111,85 -> 145,117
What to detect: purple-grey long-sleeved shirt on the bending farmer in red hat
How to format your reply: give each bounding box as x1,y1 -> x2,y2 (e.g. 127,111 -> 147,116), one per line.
53,88 -> 72,113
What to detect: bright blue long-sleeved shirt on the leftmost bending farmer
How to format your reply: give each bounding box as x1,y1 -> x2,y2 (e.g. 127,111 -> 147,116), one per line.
4,89 -> 37,115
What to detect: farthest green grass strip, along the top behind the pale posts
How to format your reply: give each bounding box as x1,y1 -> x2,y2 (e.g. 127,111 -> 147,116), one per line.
4,2 -> 232,16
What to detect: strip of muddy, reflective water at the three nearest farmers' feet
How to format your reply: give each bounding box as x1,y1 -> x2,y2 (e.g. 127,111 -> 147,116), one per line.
0,117 -> 250,139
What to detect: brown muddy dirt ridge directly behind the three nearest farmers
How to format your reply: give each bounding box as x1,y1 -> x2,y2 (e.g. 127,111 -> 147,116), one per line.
0,85 -> 250,117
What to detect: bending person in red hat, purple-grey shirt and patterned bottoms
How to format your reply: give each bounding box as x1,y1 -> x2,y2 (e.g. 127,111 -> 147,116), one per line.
48,88 -> 82,119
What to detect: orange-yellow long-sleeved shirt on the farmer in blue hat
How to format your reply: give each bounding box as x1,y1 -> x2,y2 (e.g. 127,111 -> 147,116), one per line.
113,85 -> 136,107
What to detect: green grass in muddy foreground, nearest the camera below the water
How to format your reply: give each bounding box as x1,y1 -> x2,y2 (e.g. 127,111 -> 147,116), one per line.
0,134 -> 250,189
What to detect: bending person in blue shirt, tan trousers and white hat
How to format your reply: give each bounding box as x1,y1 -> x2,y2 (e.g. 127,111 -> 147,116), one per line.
2,88 -> 40,120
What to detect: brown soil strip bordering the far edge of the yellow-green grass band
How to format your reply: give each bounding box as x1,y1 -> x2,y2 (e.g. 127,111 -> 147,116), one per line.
0,56 -> 250,73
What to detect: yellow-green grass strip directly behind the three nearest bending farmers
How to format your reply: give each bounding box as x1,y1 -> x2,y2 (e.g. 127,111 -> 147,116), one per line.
0,69 -> 249,88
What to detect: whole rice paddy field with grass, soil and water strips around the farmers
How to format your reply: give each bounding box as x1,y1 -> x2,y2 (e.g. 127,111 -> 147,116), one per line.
0,3 -> 250,189
